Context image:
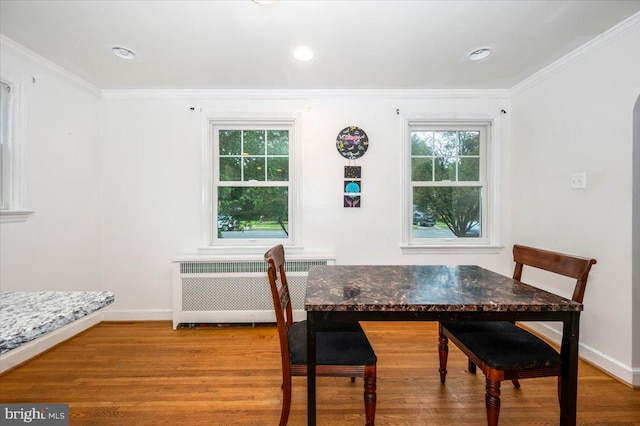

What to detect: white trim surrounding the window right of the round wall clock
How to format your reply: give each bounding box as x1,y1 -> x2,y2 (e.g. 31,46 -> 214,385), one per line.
400,114 -> 504,254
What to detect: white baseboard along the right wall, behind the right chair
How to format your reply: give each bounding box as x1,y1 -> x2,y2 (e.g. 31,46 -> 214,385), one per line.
525,322 -> 640,387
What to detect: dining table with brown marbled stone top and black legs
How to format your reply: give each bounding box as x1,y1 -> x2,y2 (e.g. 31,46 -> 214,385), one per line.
304,265 -> 583,426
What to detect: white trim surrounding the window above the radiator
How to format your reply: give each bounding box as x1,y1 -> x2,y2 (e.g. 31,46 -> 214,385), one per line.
198,111 -> 302,254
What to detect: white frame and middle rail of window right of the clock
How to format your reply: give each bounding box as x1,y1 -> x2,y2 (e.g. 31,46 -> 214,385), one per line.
401,115 -> 503,254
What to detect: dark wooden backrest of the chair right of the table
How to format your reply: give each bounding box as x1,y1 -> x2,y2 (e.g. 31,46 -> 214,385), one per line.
513,244 -> 596,303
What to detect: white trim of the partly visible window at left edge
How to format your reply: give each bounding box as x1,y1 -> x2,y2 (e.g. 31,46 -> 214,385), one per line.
0,75 -> 34,223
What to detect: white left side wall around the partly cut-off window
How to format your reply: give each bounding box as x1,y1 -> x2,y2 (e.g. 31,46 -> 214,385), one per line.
0,43 -> 102,291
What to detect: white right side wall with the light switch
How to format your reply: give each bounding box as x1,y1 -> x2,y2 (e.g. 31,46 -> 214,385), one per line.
512,25 -> 640,384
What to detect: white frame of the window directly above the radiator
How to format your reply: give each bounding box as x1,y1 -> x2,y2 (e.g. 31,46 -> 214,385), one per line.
200,113 -> 301,254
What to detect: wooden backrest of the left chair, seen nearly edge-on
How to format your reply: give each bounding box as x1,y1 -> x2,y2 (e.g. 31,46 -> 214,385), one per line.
264,244 -> 293,368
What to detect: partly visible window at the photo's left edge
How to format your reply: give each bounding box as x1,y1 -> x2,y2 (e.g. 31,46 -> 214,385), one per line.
0,81 -> 33,222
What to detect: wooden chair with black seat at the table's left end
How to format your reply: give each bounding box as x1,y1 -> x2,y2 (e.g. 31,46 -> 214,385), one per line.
264,244 -> 377,426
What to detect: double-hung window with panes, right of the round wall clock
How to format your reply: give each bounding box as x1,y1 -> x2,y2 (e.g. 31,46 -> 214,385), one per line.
406,121 -> 491,246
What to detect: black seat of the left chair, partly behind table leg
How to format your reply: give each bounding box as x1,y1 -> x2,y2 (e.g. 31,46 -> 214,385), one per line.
288,321 -> 377,365
